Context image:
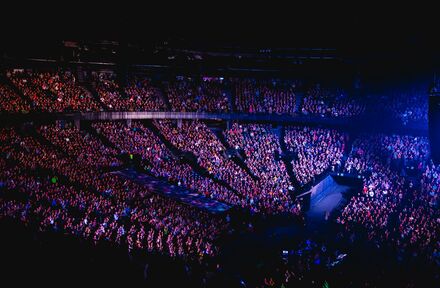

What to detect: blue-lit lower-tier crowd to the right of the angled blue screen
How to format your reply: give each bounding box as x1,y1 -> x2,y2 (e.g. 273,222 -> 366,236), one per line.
337,135 -> 440,261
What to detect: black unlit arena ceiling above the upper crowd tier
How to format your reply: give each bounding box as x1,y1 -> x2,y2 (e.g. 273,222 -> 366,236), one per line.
0,6 -> 440,75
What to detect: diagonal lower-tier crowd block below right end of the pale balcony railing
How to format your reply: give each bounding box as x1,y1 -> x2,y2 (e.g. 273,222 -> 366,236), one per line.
155,121 -> 297,214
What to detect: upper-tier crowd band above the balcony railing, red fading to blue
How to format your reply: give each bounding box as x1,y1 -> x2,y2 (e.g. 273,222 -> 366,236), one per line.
0,69 -> 428,125
